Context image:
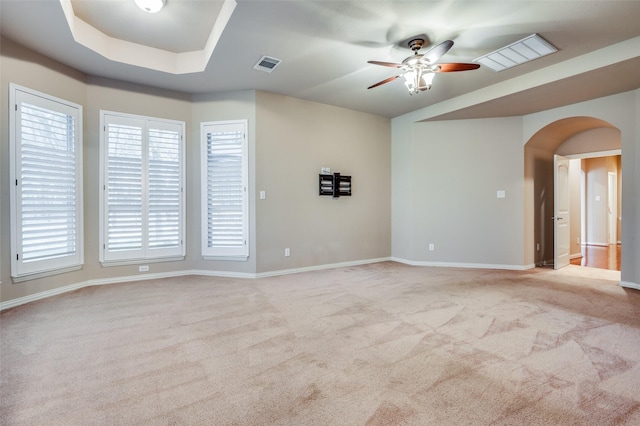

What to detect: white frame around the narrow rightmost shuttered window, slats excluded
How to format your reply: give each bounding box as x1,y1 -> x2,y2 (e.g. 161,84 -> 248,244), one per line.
200,119 -> 250,261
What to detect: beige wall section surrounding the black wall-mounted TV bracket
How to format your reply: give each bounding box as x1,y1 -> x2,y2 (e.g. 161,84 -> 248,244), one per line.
255,92 -> 391,272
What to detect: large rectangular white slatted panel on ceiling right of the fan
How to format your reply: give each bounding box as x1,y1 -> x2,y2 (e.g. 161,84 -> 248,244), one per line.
474,34 -> 558,71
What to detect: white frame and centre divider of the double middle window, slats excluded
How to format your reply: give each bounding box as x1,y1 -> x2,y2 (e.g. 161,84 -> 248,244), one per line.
99,110 -> 186,266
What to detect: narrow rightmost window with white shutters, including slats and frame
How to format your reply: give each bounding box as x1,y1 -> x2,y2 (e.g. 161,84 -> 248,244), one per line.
201,120 -> 249,260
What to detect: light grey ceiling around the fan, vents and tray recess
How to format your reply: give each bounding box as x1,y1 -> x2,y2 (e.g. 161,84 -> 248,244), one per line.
0,0 -> 640,119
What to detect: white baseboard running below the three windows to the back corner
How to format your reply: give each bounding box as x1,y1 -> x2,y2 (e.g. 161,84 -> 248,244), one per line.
0,257 -> 391,311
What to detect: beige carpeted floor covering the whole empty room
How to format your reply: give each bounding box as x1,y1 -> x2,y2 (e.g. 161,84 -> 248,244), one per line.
0,262 -> 640,425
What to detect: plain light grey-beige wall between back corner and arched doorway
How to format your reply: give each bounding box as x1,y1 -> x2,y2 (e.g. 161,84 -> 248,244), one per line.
393,118 -> 524,268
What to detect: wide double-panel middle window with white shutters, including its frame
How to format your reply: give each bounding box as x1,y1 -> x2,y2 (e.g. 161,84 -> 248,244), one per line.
100,111 -> 185,264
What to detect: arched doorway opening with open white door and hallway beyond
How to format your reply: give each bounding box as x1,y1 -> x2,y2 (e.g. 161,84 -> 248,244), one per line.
525,116 -> 622,271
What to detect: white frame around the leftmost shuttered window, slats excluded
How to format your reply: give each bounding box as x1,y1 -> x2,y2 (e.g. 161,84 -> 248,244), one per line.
9,83 -> 84,282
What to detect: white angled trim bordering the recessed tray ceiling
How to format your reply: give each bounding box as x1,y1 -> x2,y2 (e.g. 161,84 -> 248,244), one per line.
60,0 -> 237,74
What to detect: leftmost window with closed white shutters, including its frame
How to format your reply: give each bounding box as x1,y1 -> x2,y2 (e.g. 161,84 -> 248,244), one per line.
9,84 -> 83,278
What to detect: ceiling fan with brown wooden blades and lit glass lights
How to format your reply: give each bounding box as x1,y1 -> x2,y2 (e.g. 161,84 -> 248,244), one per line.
367,38 -> 480,95
